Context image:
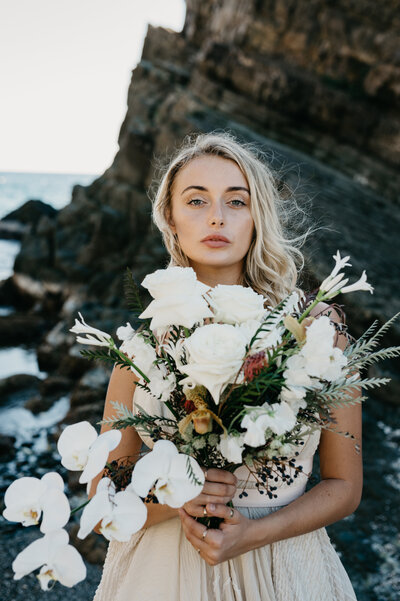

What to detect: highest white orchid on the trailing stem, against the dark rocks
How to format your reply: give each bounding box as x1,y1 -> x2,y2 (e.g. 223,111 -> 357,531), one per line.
57,421 -> 122,492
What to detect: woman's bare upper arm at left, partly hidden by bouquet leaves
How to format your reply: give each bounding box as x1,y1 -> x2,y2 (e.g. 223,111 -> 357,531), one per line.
89,365 -> 142,498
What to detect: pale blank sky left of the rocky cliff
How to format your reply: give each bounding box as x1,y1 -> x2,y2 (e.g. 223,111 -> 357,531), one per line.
0,0 -> 186,174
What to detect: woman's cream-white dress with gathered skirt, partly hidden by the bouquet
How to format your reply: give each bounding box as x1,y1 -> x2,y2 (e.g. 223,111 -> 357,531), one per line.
93,387 -> 356,601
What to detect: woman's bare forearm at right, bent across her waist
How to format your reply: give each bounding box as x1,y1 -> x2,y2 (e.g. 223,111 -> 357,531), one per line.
249,479 -> 360,549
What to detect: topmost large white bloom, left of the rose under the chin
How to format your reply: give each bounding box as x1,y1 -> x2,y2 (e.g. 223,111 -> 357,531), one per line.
139,266 -> 214,332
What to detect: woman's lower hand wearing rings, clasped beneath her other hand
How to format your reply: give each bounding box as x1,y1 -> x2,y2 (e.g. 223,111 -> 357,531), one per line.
178,504 -> 257,566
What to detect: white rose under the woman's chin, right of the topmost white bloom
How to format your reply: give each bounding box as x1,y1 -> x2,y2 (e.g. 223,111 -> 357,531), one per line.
208,284 -> 265,324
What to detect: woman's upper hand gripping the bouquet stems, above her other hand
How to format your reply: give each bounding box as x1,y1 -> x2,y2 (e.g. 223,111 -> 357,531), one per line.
183,468 -> 237,518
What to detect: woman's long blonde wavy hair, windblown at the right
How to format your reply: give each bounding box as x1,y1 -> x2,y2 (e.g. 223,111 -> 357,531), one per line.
148,130 -> 310,306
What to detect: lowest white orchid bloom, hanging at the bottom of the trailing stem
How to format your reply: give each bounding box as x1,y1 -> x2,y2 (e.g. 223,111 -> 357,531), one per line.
12,529 -> 86,591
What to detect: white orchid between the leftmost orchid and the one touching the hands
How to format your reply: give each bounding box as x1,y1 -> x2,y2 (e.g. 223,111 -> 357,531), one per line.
78,478 -> 147,542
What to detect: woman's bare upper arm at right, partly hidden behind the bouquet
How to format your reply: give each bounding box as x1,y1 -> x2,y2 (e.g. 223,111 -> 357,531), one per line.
311,303 -> 363,509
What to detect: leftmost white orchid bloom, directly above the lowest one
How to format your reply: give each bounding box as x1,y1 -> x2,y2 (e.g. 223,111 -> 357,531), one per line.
3,472 -> 71,533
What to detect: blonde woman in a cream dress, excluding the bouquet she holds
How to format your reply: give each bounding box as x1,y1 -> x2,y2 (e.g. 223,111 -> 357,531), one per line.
91,133 -> 362,601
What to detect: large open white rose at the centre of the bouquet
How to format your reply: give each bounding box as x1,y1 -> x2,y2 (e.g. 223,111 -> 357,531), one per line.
178,323 -> 246,405
